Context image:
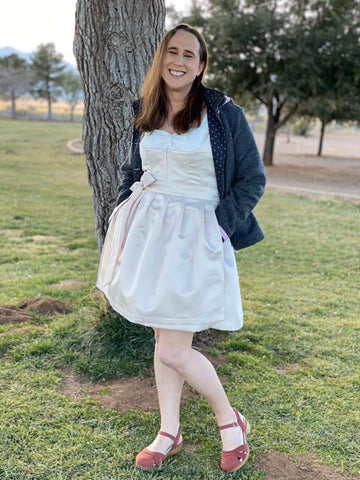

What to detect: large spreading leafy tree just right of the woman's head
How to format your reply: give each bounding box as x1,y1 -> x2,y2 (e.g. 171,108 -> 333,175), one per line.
183,0 -> 360,165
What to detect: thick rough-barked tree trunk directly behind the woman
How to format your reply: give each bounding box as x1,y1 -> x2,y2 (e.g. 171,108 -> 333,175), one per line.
73,0 -> 165,251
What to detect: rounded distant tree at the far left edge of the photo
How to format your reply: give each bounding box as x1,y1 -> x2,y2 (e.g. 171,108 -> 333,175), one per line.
0,54 -> 33,119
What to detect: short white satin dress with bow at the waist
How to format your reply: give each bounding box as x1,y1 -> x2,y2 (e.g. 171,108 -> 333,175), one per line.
96,116 -> 243,332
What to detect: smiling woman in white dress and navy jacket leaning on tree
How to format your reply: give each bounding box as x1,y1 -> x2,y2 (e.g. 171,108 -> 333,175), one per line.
97,24 -> 265,472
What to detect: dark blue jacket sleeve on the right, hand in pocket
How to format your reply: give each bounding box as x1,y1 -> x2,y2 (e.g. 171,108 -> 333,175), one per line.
216,106 -> 266,237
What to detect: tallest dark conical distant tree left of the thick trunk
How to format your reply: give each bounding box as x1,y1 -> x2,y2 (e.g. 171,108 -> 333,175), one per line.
30,43 -> 66,120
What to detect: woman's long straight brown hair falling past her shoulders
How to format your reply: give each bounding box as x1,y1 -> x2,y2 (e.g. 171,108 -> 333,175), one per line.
134,23 -> 208,134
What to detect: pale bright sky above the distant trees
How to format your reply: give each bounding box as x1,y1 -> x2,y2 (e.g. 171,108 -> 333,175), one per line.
0,0 -> 191,67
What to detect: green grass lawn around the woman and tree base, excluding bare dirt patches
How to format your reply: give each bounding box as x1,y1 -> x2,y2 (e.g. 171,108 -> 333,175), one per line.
0,120 -> 360,480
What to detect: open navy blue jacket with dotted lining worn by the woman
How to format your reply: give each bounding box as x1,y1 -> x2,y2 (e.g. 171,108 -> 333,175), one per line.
116,87 -> 266,250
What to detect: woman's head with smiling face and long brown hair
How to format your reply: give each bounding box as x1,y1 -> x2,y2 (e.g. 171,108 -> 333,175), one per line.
135,24 -> 208,134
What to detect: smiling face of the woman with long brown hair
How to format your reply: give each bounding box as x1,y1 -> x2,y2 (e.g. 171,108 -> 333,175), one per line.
161,30 -> 204,93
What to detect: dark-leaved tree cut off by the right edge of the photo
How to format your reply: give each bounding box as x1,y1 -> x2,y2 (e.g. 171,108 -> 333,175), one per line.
297,0 -> 360,156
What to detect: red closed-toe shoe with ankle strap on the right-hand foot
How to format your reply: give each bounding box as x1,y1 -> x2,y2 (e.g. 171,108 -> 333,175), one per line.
220,408 -> 251,473
